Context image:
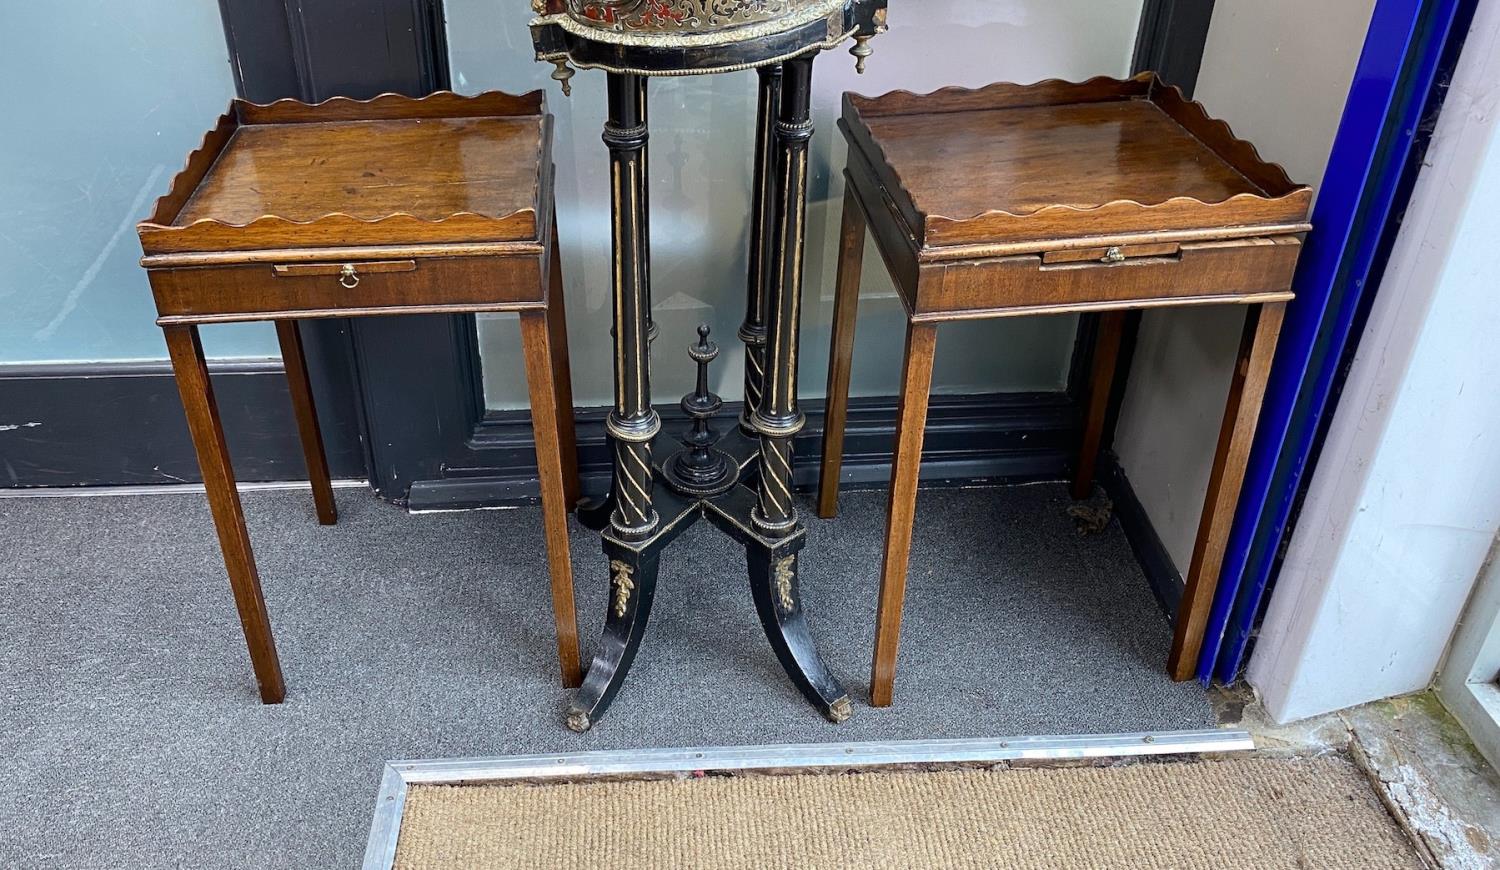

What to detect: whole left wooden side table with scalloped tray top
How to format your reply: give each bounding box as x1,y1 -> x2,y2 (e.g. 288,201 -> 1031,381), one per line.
138,92 -> 579,704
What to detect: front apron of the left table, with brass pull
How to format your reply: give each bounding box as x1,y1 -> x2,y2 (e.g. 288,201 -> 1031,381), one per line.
150,257 -> 546,321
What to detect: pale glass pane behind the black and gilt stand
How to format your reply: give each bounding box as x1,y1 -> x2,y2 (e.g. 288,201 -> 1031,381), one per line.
447,0 -> 1142,410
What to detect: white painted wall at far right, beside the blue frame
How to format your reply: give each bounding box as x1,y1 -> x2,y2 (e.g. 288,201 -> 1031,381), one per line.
1248,3 -> 1500,722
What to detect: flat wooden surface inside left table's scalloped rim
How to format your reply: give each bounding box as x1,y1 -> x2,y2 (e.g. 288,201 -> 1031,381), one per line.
173,119 -> 542,227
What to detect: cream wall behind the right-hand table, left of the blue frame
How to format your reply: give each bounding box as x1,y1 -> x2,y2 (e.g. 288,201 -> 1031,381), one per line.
1115,0 -> 1374,572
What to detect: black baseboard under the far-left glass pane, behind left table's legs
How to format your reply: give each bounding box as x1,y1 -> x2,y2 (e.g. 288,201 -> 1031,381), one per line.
0,360 -> 365,488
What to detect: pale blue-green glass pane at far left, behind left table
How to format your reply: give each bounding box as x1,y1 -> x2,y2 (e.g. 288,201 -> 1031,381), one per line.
0,0 -> 278,363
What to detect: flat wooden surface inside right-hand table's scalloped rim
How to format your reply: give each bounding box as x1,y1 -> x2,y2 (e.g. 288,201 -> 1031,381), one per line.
869,101 -> 1265,219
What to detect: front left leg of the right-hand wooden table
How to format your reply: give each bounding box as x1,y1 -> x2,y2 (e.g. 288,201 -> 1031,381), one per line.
870,323 -> 938,707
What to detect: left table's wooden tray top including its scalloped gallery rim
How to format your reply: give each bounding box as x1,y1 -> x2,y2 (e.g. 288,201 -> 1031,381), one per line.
140,93 -> 551,255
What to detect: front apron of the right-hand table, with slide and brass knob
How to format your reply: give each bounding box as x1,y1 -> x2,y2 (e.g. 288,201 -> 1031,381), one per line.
915,236 -> 1302,318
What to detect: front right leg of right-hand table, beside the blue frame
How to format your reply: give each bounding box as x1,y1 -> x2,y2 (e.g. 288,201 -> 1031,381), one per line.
1167,302 -> 1287,681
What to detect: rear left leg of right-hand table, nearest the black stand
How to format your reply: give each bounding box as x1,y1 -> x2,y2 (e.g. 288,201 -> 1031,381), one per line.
818,185 -> 866,519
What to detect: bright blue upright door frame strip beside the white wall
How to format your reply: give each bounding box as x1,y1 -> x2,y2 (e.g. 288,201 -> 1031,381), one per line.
1197,0 -> 1478,684
